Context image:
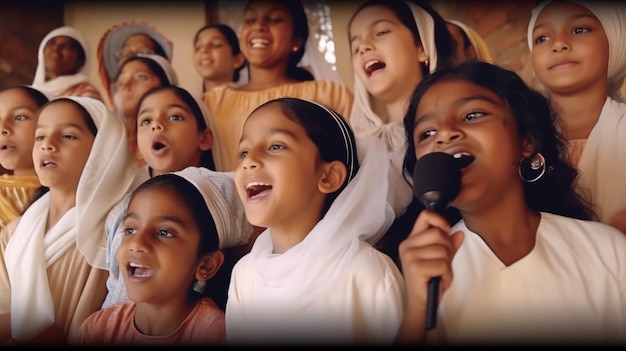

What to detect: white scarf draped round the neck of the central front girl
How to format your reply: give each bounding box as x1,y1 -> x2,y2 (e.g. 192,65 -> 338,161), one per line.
248,104 -> 394,302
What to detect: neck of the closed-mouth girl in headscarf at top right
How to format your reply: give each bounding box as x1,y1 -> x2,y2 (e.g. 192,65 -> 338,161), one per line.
550,84 -> 607,140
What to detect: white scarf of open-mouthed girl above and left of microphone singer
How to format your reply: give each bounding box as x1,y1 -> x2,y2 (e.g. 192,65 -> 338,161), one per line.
350,1 -> 437,216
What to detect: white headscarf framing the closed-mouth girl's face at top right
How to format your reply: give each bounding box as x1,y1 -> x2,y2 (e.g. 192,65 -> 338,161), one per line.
527,0 -> 626,83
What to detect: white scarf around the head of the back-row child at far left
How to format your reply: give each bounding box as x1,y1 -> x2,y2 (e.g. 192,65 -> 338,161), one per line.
32,26 -> 89,97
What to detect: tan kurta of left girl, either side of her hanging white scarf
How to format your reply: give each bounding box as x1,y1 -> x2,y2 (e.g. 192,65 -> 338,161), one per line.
0,220 -> 108,343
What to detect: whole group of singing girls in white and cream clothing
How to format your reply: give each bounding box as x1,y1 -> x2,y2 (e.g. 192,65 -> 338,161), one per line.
0,0 -> 626,345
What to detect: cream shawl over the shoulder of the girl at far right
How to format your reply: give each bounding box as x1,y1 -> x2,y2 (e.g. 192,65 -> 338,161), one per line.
578,97 -> 626,223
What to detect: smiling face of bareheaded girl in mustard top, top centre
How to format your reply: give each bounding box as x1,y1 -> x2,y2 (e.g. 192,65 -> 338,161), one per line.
239,0 -> 302,71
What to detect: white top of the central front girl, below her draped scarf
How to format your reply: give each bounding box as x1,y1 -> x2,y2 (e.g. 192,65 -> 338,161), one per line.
226,242 -> 404,345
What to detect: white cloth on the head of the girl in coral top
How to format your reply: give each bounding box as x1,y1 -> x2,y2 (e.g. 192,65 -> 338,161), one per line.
174,167 -> 252,250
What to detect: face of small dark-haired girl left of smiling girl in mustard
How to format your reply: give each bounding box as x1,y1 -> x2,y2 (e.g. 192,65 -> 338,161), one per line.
193,28 -> 242,82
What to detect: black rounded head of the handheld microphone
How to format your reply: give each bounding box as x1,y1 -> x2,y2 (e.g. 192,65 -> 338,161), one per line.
413,152 -> 467,214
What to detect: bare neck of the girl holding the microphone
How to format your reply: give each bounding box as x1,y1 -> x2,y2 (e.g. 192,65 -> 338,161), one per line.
461,186 -> 540,266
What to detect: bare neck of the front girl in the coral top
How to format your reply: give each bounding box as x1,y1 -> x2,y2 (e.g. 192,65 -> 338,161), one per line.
134,297 -> 195,336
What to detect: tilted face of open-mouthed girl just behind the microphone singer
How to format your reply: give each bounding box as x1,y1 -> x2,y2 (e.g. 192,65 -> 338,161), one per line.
349,6 -> 426,103
